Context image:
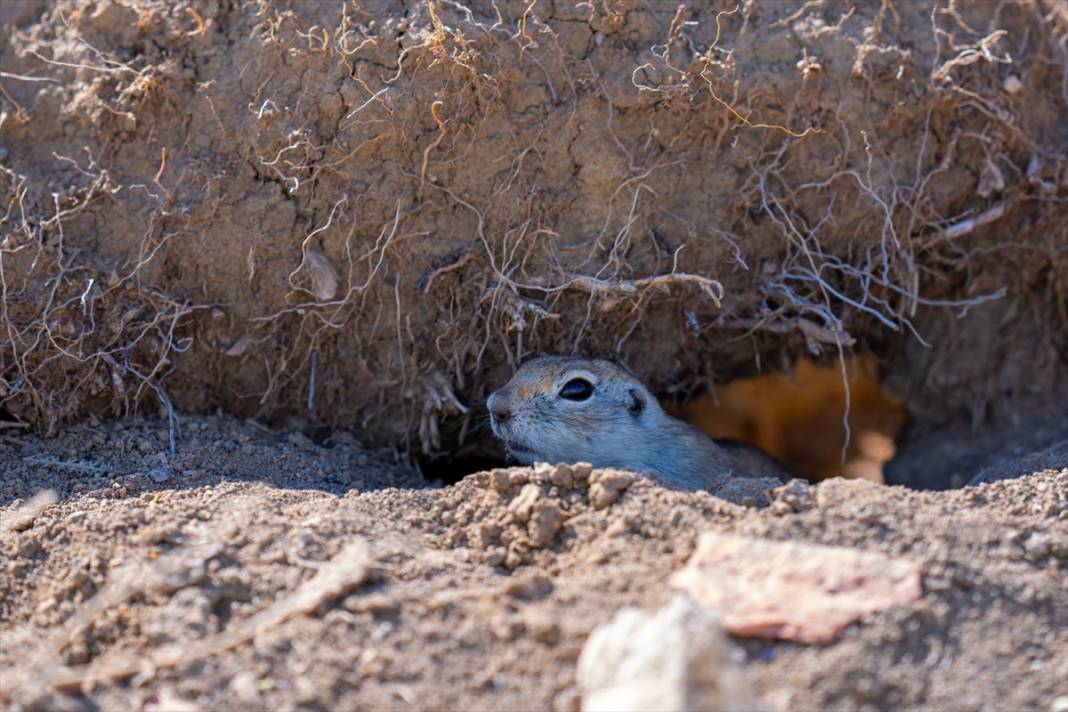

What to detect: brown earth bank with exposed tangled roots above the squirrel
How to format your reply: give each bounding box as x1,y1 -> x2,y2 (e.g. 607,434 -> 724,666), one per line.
0,0 -> 1068,453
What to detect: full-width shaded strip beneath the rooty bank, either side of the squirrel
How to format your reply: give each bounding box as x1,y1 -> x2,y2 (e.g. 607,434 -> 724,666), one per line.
0,373 -> 1068,506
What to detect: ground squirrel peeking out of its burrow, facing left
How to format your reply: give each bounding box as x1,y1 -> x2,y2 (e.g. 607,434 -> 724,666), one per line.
486,355 -> 786,492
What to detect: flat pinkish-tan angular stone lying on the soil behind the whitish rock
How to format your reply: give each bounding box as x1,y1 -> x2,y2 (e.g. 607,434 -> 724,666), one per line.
672,532 -> 923,643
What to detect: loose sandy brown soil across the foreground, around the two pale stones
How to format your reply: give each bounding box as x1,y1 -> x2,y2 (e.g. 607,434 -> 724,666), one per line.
0,416 -> 1068,710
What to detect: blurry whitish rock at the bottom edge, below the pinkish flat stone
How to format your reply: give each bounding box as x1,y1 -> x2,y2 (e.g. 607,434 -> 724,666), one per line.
577,596 -> 760,712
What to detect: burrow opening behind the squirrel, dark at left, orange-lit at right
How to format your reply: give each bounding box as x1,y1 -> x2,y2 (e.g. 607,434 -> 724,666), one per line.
417,357 -> 1068,490
